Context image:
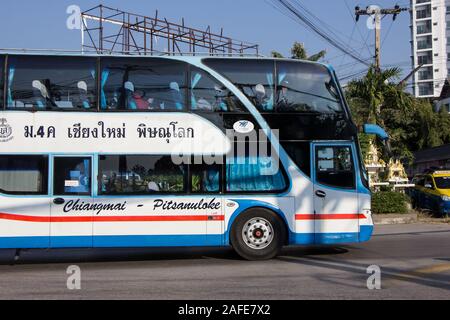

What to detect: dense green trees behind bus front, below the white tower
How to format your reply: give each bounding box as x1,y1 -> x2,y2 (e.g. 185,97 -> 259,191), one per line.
346,67 -> 450,164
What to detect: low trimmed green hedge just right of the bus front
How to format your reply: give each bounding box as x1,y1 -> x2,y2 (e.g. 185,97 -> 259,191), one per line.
372,191 -> 408,213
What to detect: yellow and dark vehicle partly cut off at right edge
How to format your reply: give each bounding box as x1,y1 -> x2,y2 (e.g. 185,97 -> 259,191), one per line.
411,170 -> 450,216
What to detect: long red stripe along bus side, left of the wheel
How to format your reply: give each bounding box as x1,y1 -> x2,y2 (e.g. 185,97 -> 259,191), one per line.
0,213 -> 225,222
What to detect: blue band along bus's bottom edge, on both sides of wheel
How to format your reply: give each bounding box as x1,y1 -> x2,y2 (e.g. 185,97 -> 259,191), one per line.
0,226 -> 373,249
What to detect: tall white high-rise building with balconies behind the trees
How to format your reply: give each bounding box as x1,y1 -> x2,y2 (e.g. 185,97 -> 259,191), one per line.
411,0 -> 450,98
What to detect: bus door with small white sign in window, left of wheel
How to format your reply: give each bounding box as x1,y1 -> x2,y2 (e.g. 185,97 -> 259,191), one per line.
50,155 -> 94,248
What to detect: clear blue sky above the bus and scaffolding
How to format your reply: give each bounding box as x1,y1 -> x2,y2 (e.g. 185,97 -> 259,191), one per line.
0,0 -> 411,78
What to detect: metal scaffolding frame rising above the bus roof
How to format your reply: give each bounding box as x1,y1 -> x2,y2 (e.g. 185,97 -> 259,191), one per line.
81,5 -> 259,55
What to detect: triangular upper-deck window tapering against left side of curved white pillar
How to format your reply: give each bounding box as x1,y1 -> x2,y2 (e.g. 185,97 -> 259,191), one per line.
191,67 -> 245,112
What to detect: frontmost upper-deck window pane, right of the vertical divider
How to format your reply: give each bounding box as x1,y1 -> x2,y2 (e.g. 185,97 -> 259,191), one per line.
276,62 -> 343,113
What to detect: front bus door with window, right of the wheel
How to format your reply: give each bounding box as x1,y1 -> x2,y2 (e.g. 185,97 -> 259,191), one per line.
311,143 -> 359,243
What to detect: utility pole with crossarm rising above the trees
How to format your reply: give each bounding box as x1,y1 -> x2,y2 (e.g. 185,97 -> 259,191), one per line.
355,5 -> 409,72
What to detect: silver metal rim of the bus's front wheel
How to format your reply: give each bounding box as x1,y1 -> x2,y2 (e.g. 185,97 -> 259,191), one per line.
242,218 -> 274,250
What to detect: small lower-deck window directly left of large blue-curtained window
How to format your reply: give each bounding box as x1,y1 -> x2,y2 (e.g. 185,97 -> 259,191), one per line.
190,164 -> 222,193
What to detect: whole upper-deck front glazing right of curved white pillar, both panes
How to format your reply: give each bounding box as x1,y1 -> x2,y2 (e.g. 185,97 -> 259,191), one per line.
205,59 -> 343,113
